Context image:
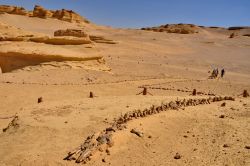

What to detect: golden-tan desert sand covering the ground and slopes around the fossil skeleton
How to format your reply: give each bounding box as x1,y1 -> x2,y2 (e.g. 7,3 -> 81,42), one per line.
0,4 -> 250,166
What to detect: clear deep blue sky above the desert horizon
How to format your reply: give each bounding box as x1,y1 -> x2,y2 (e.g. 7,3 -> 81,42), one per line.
0,0 -> 250,28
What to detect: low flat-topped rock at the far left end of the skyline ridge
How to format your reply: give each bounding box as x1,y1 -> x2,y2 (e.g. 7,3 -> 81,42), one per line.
0,5 -> 29,16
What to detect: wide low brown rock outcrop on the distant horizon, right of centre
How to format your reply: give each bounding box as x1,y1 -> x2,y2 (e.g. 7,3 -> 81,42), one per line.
141,24 -> 199,34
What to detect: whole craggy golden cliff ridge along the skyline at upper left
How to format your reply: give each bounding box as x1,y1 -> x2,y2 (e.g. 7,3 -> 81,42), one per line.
0,5 -> 89,23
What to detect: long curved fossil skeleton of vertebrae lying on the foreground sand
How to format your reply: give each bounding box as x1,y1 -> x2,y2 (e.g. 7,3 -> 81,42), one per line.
64,96 -> 235,163
